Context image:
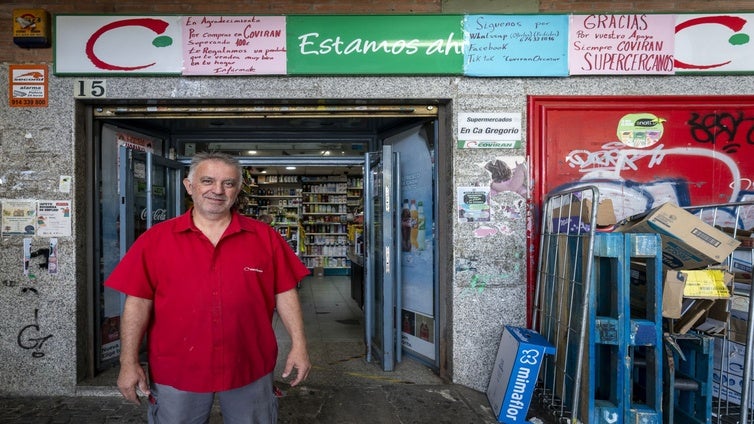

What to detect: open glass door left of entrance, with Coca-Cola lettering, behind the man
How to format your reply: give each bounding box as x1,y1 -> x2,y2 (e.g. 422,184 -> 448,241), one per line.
95,125 -> 185,371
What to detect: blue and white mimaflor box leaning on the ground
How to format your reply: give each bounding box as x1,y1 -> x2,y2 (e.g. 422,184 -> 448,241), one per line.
487,325 -> 555,424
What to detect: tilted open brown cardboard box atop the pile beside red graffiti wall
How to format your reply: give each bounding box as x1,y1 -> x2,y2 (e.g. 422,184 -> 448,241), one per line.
616,203 -> 741,269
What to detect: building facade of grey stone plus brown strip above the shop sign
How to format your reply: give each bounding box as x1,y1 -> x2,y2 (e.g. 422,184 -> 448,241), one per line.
0,0 -> 754,395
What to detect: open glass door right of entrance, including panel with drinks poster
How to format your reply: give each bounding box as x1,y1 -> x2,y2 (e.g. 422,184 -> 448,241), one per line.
364,121 -> 439,371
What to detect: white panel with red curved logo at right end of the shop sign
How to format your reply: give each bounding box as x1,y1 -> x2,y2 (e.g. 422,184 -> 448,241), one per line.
675,13 -> 754,73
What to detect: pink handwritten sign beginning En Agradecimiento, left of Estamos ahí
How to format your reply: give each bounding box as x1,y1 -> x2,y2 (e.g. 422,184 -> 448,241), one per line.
183,16 -> 286,76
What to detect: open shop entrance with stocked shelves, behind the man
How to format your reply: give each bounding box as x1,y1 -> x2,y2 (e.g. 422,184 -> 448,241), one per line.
83,103 -> 440,384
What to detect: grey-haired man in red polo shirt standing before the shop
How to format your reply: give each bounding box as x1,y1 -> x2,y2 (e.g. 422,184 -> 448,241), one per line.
105,153 -> 311,424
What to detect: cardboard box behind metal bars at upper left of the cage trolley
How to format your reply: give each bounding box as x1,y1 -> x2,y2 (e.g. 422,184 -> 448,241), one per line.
552,199 -> 616,234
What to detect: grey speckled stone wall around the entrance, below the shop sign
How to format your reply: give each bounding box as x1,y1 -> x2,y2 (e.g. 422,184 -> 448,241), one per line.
0,64 -> 754,395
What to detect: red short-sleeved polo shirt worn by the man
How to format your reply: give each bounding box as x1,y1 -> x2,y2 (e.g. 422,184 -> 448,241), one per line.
105,211 -> 309,392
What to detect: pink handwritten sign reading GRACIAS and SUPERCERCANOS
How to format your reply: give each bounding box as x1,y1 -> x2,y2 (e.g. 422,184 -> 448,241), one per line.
568,15 -> 675,75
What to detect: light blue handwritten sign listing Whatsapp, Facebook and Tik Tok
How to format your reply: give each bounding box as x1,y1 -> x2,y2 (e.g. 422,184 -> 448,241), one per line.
463,15 -> 568,76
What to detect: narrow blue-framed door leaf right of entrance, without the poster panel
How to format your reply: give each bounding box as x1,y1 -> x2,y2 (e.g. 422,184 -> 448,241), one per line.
364,145 -> 401,371
